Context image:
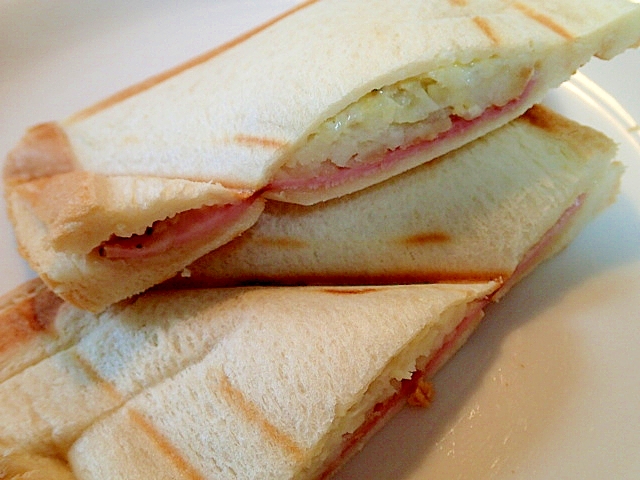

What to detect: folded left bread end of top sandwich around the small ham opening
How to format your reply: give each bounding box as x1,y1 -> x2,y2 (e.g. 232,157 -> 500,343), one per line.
6,171 -> 264,312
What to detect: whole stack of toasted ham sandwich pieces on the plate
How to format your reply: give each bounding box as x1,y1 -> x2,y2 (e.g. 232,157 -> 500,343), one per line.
0,0 -> 640,479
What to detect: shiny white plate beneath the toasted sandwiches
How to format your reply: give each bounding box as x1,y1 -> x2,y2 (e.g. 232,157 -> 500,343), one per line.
0,0 -> 640,480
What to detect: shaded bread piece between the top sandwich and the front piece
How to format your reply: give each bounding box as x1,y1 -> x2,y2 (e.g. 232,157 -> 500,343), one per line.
168,106 -> 623,287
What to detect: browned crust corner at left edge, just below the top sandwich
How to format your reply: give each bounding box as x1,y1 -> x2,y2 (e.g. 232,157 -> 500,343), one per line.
0,279 -> 64,353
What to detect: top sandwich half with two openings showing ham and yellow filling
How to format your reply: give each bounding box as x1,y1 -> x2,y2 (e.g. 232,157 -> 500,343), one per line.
4,0 -> 640,310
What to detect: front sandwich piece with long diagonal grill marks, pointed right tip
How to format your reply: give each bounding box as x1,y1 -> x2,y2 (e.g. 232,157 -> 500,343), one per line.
0,282 -> 499,479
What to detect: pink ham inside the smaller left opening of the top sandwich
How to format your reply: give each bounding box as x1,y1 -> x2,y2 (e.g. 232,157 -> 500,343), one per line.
97,198 -> 255,260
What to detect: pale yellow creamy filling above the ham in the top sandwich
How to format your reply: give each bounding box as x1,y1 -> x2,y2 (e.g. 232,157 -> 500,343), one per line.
286,59 -> 533,168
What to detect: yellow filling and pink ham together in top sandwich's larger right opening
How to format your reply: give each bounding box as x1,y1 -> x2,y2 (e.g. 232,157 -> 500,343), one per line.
269,59 -> 535,191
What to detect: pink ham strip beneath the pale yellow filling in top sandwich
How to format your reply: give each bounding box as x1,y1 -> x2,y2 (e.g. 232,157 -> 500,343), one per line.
267,80 -> 535,191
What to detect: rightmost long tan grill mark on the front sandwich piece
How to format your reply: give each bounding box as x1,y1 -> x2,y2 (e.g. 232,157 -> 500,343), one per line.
220,374 -> 304,462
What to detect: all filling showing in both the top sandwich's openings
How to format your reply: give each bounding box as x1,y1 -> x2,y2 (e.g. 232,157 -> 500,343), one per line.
95,60 -> 533,260
